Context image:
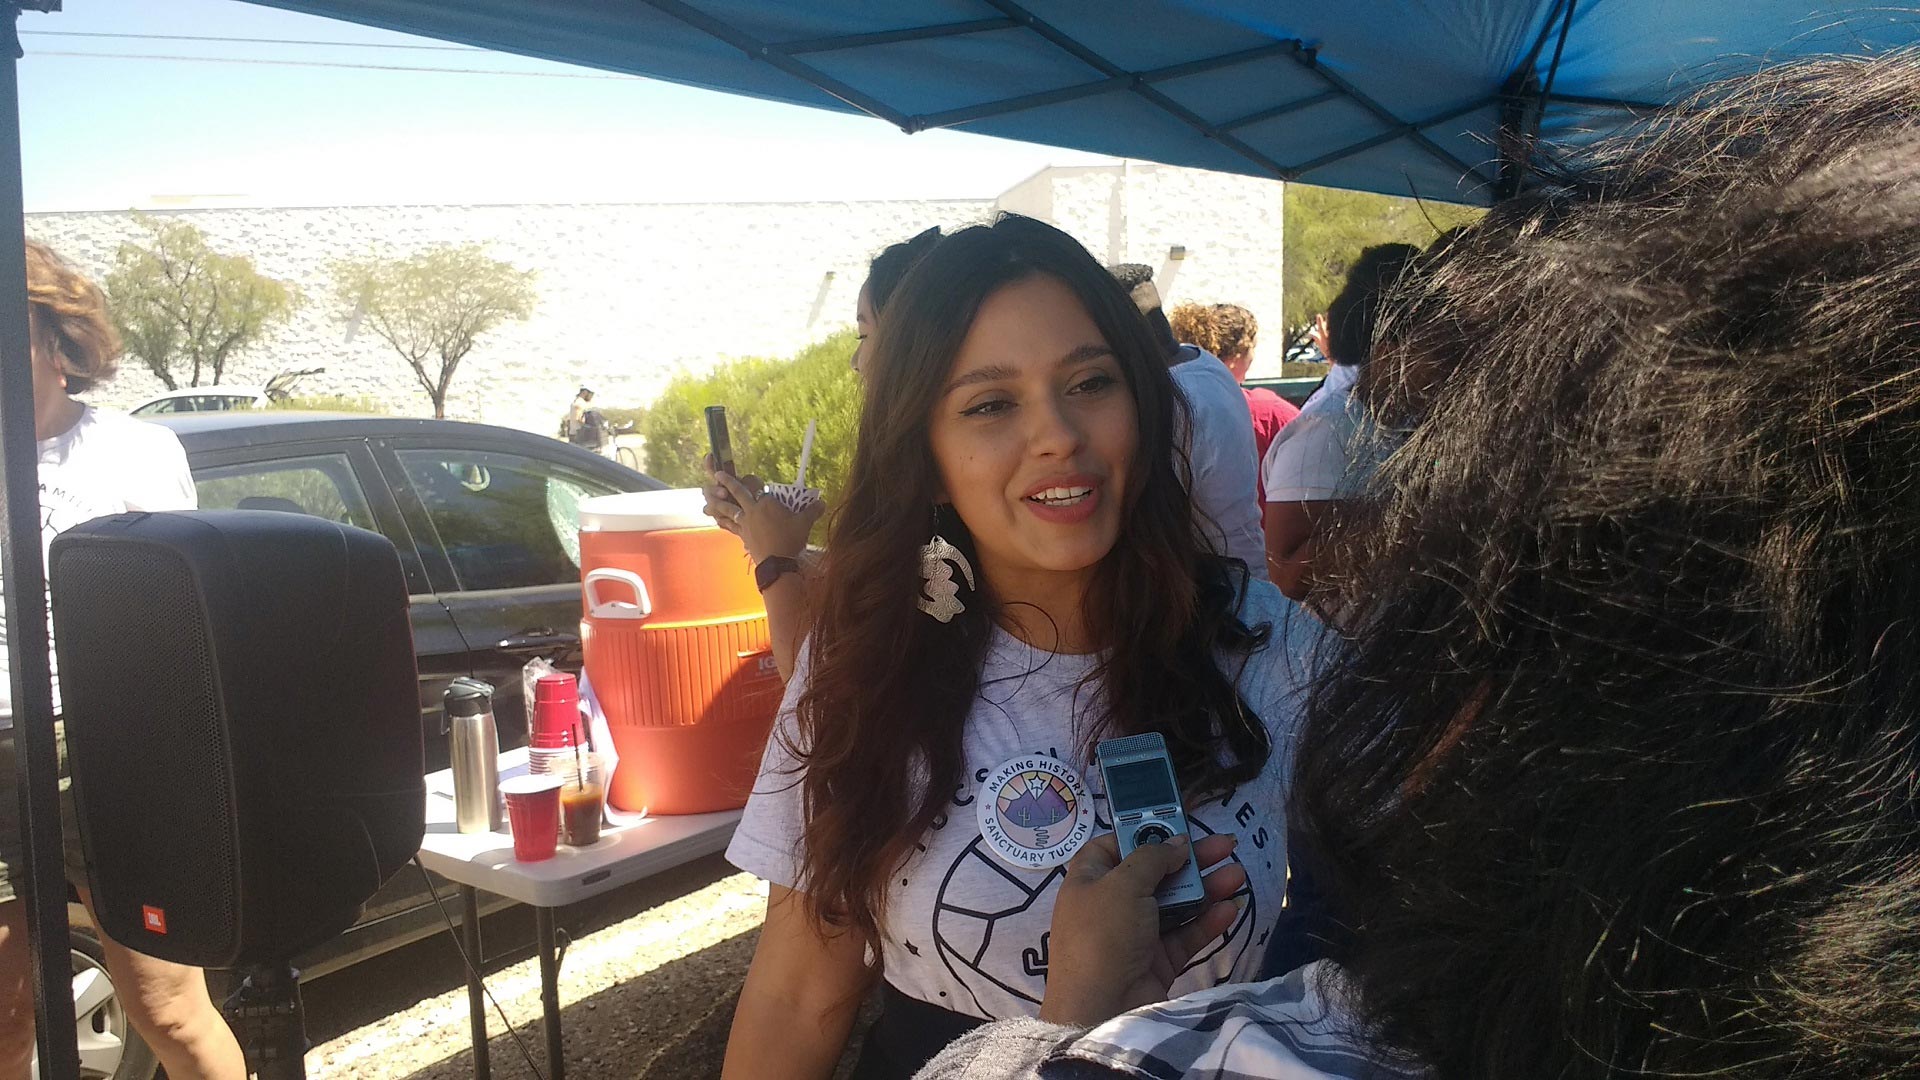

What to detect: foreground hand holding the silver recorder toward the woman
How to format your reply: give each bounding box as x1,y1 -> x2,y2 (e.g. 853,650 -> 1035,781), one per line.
1041,834 -> 1246,1028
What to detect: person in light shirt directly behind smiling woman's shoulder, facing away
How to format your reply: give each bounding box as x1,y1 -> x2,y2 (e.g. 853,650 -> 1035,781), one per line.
1108,263 -> 1267,580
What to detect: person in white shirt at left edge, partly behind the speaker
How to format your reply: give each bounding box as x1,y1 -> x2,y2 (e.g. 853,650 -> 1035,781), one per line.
0,240 -> 246,1080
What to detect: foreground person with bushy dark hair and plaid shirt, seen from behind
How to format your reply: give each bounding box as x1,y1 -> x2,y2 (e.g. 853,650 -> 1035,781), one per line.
922,52 -> 1920,1080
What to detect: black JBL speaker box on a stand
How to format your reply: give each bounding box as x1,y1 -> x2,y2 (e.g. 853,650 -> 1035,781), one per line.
48,509 -> 426,967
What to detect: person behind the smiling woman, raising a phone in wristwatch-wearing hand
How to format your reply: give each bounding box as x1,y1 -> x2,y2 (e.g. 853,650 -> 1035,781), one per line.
705,225 -> 941,678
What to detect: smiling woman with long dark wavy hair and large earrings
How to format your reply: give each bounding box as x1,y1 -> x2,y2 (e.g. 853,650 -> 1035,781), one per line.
726,217 -> 1294,1078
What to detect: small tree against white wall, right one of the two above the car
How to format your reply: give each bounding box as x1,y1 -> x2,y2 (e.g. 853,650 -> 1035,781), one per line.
334,244 -> 536,419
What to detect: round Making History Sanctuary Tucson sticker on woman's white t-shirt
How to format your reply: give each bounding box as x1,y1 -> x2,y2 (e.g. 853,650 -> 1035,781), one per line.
975,753 -> 1092,871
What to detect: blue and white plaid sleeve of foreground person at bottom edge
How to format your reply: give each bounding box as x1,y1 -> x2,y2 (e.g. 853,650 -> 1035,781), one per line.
916,961 -> 1427,1080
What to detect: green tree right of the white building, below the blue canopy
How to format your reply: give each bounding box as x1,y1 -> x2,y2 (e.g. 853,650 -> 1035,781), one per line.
1281,184 -> 1484,340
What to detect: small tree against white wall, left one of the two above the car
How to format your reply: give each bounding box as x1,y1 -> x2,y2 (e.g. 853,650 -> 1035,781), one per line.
106,217 -> 301,390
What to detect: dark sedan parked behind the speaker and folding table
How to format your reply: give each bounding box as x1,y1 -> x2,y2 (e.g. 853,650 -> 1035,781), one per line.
154,409 -> 664,976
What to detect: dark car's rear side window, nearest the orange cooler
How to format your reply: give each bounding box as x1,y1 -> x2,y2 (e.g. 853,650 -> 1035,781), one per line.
399,450 -> 620,592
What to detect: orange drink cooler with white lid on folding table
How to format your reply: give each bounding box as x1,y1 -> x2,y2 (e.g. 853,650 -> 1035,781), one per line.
580,488 -> 785,813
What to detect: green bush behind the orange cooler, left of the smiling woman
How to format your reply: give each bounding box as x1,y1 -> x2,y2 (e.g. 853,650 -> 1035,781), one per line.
639,331 -> 860,505
